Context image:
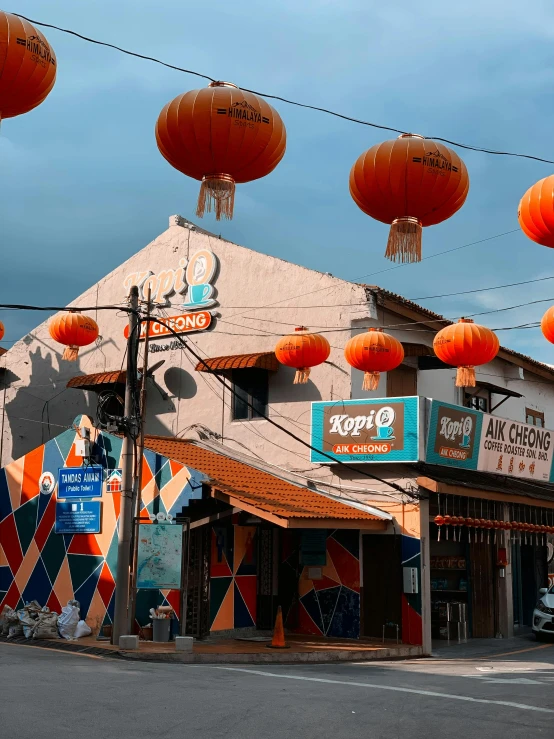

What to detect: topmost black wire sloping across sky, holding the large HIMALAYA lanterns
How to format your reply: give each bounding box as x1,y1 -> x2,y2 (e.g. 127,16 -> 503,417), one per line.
13,13 -> 554,164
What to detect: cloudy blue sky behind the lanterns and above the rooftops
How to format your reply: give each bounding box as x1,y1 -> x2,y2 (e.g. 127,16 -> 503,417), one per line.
0,0 -> 554,362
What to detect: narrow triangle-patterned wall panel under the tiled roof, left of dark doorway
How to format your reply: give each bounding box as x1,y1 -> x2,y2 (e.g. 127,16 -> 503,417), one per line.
210,525 -> 258,631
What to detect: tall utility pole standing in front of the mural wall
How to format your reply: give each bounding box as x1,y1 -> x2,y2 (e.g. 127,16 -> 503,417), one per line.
112,285 -> 139,645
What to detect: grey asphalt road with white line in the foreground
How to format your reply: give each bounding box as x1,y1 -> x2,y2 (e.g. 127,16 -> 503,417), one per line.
0,638 -> 554,739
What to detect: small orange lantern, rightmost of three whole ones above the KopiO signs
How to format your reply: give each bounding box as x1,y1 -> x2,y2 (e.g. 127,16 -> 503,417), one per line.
433,318 -> 500,387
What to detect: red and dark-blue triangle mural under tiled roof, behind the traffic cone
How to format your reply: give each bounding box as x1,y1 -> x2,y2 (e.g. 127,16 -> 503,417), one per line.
279,529 -> 360,639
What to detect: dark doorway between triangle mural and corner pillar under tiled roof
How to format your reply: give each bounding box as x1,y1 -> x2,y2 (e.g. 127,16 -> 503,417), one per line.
362,534 -> 402,639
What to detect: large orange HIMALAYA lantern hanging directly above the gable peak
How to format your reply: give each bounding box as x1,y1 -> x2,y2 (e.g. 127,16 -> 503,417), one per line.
156,82 -> 287,221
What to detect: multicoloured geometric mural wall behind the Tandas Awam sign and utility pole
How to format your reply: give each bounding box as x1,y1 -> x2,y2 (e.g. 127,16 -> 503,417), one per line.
0,419 -> 202,633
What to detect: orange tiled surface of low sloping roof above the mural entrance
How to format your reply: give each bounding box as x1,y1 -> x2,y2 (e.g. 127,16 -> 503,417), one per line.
144,436 -> 388,527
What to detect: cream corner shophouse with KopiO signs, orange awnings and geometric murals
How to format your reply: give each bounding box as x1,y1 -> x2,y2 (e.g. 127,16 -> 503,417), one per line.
0,216 -> 554,651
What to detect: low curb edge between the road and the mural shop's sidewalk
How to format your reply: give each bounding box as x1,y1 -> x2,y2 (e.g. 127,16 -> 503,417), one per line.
0,636 -> 423,665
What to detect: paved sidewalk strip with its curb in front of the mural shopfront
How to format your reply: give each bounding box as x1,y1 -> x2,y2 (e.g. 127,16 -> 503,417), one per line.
0,635 -> 422,664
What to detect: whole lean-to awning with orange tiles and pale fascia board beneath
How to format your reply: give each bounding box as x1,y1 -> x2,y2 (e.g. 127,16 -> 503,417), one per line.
145,436 -> 391,530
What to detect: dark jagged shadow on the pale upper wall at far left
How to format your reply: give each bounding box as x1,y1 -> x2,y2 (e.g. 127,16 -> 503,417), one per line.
1,346 -> 95,464
